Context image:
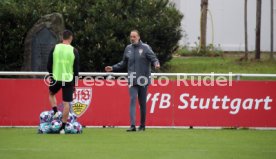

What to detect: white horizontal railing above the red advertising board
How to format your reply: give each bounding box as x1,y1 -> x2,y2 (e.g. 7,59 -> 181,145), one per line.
0,71 -> 276,80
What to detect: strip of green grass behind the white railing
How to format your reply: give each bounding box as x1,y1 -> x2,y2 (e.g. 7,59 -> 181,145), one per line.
162,56 -> 276,80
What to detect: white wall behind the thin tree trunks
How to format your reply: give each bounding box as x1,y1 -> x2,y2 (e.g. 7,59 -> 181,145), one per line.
172,0 -> 276,51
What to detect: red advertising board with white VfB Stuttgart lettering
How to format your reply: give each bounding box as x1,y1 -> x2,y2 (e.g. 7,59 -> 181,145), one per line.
0,79 -> 276,127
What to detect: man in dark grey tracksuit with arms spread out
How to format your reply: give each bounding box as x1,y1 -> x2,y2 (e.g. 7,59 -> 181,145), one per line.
105,30 -> 160,132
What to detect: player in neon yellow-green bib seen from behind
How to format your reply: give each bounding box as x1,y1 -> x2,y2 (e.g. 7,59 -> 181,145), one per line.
47,30 -> 79,134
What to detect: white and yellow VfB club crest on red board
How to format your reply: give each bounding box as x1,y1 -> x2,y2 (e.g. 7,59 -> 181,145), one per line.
71,87 -> 92,117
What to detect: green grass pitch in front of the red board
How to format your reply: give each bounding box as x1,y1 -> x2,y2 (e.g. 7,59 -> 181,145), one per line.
0,128 -> 276,159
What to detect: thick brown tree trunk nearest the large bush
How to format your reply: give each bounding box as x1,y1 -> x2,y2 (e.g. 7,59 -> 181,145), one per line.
200,0 -> 208,51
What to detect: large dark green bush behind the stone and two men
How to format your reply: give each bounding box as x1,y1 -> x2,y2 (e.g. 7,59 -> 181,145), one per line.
0,0 -> 183,71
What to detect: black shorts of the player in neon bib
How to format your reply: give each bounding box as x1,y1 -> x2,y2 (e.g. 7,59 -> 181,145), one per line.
49,80 -> 75,102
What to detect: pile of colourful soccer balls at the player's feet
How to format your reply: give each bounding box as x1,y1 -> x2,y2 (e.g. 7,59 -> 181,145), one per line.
38,110 -> 82,134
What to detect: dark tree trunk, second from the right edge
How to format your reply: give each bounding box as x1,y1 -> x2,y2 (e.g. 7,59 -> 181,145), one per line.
255,0 -> 262,60
